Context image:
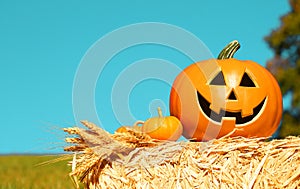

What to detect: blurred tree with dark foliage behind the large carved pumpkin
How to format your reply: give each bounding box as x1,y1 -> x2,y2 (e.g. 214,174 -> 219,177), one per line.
265,0 -> 300,138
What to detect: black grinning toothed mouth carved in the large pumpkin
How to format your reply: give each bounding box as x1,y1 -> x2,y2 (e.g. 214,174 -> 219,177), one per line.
197,91 -> 266,124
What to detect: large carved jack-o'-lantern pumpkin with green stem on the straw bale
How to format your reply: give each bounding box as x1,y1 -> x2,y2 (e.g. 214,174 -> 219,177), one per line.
170,41 -> 282,141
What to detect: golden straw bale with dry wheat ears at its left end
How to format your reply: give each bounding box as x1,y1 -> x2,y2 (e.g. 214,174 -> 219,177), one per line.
64,121 -> 300,189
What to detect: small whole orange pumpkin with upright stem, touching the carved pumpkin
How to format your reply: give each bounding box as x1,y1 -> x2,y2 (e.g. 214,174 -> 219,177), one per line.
141,107 -> 183,141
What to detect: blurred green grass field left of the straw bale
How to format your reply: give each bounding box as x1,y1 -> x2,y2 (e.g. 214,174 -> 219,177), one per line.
0,155 -> 74,189
